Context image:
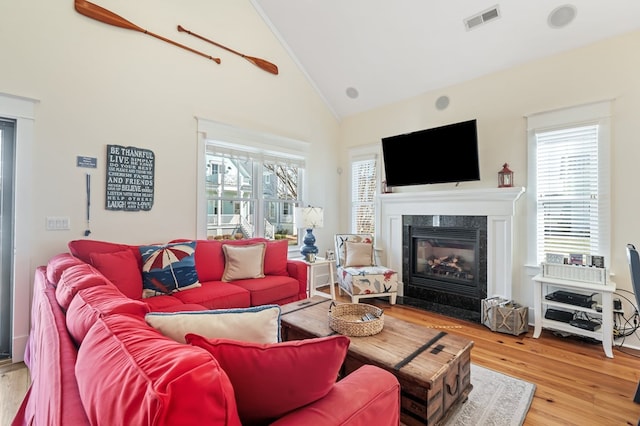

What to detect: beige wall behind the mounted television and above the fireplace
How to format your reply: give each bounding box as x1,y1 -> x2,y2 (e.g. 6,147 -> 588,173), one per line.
340,32 -> 640,330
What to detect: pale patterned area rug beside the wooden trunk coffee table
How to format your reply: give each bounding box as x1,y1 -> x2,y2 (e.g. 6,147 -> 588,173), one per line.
444,364 -> 536,426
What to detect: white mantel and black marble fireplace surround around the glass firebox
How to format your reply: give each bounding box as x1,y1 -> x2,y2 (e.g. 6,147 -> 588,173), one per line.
376,187 -> 524,321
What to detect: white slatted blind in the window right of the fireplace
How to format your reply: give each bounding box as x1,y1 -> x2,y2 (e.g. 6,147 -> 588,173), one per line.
535,124 -> 602,260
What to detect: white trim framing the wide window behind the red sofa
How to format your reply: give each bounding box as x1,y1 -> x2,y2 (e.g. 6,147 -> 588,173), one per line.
195,117 -> 311,239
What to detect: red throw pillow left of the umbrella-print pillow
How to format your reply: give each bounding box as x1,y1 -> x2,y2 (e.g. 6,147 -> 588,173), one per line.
89,250 -> 142,300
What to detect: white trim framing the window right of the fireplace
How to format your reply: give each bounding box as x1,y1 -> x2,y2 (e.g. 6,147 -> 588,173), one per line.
525,100 -> 613,268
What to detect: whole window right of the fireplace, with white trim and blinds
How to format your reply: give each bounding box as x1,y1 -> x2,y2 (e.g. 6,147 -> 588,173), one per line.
529,102 -> 610,263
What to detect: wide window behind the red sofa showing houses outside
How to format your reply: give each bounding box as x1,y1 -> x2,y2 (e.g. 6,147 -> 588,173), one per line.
198,121 -> 305,246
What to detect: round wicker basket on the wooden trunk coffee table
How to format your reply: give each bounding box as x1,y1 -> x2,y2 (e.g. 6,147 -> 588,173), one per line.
329,302 -> 384,337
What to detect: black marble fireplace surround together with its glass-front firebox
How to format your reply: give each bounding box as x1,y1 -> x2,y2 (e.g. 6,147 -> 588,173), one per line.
398,215 -> 487,322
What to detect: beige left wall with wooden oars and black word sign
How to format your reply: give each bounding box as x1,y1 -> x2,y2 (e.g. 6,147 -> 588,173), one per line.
0,0 -> 339,360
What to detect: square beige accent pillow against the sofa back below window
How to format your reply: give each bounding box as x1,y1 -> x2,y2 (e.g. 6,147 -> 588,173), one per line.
222,243 -> 267,282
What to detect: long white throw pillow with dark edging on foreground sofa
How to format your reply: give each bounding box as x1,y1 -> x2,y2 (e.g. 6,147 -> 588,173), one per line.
145,305 -> 280,343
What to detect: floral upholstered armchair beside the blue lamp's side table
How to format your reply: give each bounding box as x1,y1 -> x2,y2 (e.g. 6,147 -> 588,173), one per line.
335,234 -> 398,305
